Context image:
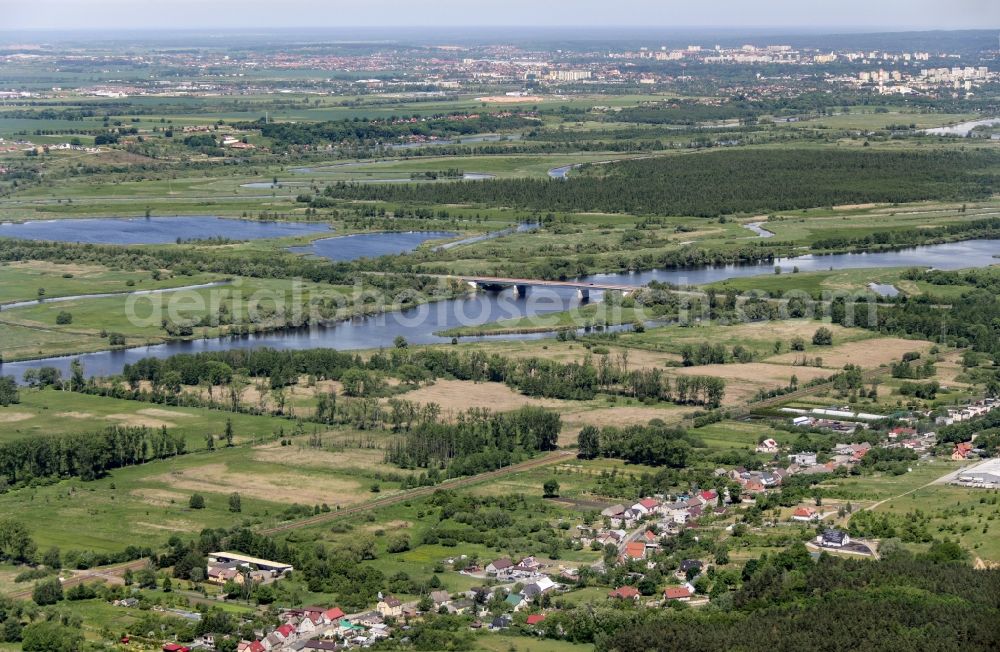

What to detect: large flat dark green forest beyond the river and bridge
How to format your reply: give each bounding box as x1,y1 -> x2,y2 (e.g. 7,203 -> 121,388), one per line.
325,149 -> 998,217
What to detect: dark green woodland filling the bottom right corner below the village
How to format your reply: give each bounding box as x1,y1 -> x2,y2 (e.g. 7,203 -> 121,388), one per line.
545,542 -> 1000,652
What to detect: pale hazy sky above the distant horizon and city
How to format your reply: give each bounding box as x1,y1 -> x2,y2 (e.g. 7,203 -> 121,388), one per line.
0,0 -> 1000,32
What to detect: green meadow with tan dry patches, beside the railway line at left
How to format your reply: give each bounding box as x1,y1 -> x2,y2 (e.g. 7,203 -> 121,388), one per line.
0,430 -> 414,552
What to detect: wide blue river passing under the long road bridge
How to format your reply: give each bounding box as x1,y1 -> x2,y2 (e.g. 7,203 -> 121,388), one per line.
0,240 -> 1000,379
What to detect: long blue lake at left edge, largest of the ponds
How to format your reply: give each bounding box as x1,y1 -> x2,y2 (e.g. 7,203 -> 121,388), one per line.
0,215 -> 330,245
